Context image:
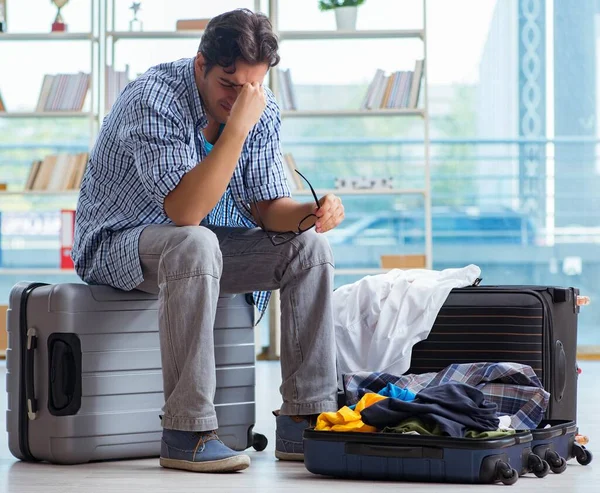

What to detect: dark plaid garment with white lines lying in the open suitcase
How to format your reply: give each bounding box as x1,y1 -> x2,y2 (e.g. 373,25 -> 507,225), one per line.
343,363 -> 550,430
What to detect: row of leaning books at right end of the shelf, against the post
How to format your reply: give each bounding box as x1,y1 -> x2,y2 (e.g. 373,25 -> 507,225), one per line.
361,60 -> 423,110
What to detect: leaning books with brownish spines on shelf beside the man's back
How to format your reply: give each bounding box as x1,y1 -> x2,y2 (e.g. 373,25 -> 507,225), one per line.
24,152 -> 88,192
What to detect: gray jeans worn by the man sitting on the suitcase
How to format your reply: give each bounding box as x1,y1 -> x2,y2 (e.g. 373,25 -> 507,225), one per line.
138,225 -> 337,431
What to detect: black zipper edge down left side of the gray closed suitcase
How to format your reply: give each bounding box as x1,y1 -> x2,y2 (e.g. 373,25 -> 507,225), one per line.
18,282 -> 47,461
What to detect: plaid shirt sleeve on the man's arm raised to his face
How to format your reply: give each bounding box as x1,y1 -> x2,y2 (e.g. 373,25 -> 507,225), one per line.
119,91 -> 197,211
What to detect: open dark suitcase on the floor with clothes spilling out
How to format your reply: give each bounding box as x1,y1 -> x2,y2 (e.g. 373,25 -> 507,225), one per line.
304,286 -> 591,484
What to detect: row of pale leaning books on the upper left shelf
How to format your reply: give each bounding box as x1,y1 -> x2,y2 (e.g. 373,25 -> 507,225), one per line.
36,72 -> 91,111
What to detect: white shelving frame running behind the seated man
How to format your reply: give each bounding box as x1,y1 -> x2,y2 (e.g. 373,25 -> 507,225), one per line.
0,0 -> 432,360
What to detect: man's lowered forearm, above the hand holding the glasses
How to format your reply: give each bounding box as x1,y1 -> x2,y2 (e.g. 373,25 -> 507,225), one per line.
253,197 -> 316,232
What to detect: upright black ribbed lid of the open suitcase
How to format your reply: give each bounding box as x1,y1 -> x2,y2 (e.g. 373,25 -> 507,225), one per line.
406,286 -> 580,421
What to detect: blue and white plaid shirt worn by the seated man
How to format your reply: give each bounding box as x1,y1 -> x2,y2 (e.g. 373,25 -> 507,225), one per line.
72,58 -> 290,312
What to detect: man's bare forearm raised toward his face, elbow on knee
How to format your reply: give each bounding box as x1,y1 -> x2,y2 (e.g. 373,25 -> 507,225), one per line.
164,127 -> 246,226
